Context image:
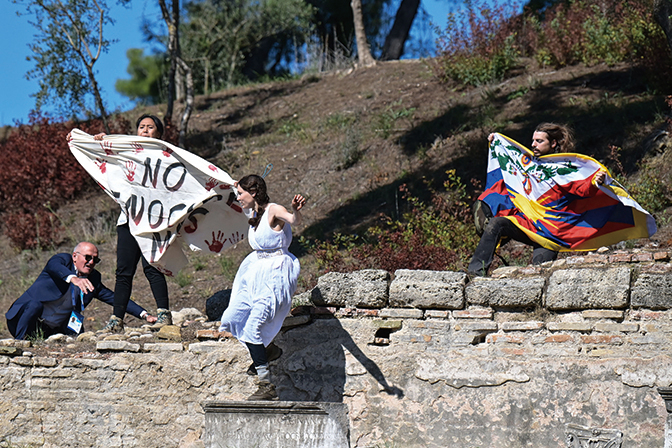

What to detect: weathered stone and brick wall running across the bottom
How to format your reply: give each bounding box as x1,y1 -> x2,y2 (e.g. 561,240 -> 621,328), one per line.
0,254 -> 672,448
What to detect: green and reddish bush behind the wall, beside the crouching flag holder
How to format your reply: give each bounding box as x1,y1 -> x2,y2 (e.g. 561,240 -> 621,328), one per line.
300,170 -> 478,272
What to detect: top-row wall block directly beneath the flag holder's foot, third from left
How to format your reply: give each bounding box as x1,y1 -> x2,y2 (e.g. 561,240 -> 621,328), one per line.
465,277 -> 546,308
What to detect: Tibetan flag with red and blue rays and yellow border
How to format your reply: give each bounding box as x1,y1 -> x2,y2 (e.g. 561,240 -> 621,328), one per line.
479,134 -> 657,251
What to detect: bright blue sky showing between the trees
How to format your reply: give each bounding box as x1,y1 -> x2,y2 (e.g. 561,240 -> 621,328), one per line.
0,0 -> 455,126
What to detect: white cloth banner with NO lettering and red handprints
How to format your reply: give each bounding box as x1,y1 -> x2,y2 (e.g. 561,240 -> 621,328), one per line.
68,129 -> 249,275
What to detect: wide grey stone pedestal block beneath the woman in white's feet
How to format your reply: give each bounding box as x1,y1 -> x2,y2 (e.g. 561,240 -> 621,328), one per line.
203,401 -> 350,448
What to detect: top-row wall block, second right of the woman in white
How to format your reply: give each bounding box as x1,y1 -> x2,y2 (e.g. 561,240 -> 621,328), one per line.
390,269 -> 467,310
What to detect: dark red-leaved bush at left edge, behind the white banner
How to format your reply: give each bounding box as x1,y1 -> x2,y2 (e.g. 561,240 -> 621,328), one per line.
0,114 -> 129,249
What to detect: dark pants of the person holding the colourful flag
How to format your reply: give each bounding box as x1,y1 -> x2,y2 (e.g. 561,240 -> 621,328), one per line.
469,217 -> 558,276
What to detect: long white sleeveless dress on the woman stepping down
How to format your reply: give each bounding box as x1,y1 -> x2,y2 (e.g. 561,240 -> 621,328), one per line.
219,204 -> 301,346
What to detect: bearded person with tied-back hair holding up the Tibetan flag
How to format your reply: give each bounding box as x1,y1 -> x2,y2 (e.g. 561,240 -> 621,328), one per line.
468,123 -> 606,276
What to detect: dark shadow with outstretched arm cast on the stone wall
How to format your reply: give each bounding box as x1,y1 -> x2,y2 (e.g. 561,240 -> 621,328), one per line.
271,317 -> 404,402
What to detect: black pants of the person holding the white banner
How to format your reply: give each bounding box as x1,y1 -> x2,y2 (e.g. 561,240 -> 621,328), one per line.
114,224 -> 169,319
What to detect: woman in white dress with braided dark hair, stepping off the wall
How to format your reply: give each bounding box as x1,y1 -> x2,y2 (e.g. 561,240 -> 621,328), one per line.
219,174 -> 306,400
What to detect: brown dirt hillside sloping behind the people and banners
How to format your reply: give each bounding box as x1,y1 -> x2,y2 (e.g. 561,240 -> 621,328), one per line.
0,60 -> 670,337
